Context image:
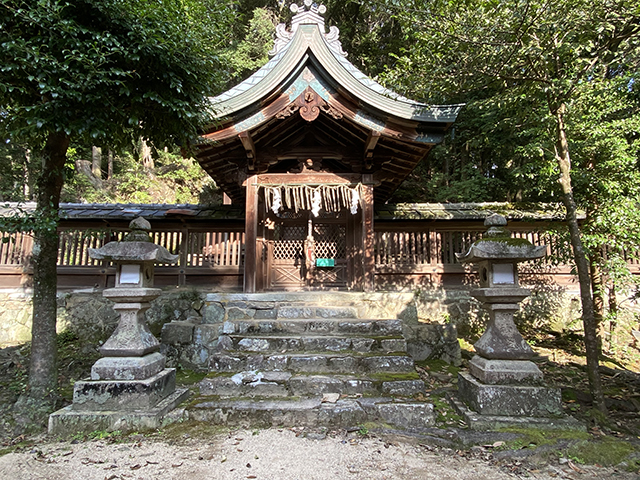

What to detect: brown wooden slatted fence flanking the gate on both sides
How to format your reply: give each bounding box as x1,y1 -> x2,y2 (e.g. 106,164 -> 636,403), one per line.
0,225 -> 640,288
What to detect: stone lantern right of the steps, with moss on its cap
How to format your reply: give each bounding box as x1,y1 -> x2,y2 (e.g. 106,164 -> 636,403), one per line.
457,215 -> 562,424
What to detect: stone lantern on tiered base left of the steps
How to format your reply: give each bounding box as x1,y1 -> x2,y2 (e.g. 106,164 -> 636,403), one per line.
49,217 -> 188,433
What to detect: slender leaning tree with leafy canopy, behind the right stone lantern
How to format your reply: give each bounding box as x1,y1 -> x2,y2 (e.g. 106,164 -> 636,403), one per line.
386,0 -> 640,412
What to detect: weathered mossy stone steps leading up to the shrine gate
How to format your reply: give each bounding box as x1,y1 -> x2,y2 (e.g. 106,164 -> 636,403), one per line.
188,305 -> 433,429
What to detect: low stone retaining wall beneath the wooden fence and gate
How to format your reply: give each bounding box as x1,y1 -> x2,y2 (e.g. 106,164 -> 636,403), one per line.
0,289 -> 579,370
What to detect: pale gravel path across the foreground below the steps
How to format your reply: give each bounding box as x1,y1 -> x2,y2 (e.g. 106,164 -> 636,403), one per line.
0,429 -> 638,480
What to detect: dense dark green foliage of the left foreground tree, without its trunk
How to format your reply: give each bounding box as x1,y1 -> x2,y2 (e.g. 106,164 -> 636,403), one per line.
0,0 -> 231,148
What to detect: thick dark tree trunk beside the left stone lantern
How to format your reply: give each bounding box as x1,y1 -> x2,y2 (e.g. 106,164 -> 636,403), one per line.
28,129 -> 69,399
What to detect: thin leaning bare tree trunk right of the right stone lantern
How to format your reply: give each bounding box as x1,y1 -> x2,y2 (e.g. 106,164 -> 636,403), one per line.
554,103 -> 607,414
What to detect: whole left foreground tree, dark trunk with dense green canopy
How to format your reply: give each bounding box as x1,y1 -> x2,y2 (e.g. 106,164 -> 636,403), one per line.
0,0 -> 232,412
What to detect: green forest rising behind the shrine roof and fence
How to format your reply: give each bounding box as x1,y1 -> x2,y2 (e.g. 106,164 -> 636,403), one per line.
0,0 -> 640,416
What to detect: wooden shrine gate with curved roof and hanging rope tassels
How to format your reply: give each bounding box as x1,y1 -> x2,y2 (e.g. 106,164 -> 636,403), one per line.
197,0 -> 461,293
